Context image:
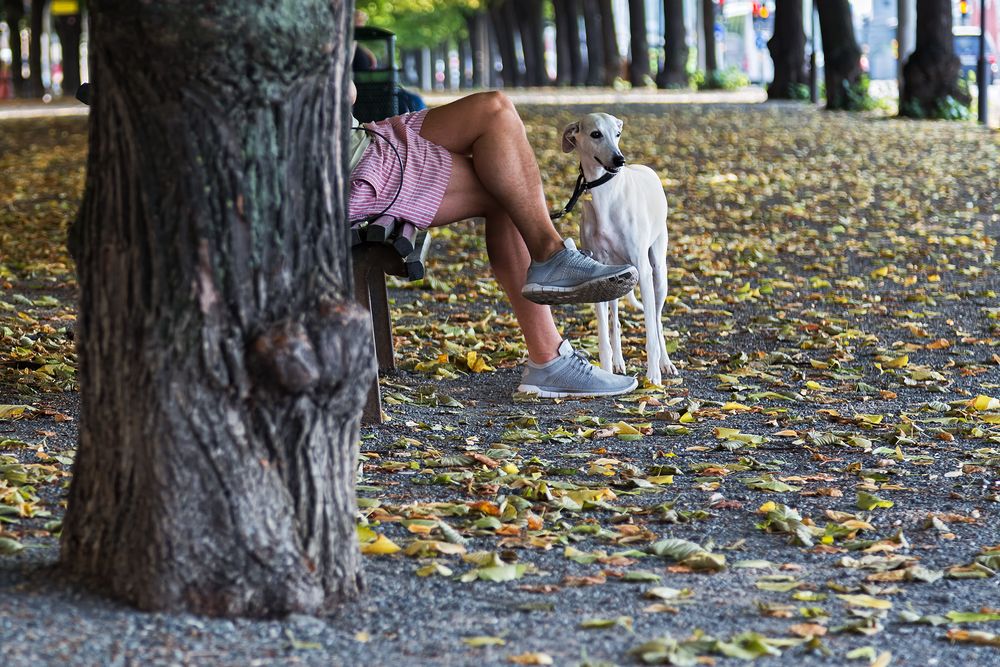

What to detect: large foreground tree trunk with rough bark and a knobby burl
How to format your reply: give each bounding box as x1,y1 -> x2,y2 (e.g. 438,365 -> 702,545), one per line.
61,0 -> 374,616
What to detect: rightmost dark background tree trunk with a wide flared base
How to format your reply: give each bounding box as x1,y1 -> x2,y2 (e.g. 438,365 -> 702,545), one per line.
899,0 -> 969,118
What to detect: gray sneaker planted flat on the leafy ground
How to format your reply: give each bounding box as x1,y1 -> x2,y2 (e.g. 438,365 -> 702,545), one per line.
517,340 -> 638,398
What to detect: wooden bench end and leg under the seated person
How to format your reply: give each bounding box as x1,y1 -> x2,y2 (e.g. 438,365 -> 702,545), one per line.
351,215 -> 431,424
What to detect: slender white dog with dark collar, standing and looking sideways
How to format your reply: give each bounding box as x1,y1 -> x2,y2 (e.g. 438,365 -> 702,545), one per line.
562,113 -> 677,384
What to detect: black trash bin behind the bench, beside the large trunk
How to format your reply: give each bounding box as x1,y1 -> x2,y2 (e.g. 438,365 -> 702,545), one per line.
352,26 -> 399,123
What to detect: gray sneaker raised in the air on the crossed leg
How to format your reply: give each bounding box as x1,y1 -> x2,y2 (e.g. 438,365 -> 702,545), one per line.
521,239 -> 639,305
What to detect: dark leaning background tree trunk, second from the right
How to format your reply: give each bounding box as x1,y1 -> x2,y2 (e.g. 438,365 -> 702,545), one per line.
816,0 -> 861,109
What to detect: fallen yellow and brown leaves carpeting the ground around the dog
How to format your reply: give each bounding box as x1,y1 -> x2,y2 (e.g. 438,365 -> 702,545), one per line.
0,106 -> 1000,665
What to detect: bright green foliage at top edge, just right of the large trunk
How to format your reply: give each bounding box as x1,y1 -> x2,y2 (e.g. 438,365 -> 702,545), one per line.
357,0 -> 483,48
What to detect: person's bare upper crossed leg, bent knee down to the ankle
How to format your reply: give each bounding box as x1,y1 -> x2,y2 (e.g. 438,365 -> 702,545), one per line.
420,92 -> 562,264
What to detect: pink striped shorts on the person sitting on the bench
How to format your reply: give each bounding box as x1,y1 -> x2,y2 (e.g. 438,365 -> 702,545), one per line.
347,109 -> 451,229
